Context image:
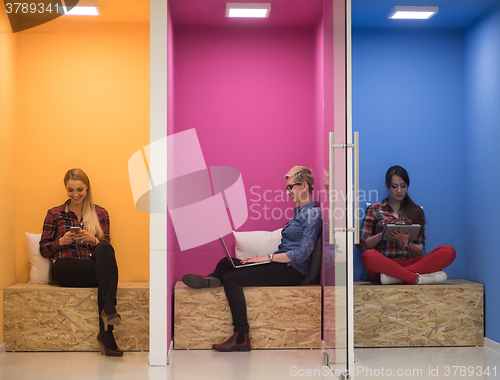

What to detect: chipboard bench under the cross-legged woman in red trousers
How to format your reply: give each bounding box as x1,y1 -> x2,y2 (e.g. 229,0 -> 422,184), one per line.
354,280 -> 484,347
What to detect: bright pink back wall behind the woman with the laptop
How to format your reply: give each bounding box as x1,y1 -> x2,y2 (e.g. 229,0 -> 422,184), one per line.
169,26 -> 322,280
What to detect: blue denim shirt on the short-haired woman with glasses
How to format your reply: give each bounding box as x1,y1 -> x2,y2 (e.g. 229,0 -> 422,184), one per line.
274,201 -> 321,276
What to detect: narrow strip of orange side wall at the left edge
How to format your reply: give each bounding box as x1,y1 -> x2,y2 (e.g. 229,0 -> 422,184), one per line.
0,1 -> 16,344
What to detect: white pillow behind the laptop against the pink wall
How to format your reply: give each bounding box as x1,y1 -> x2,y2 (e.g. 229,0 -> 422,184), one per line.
233,228 -> 283,260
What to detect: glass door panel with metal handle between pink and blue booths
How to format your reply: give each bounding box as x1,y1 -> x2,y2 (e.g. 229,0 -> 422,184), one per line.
323,0 -> 353,378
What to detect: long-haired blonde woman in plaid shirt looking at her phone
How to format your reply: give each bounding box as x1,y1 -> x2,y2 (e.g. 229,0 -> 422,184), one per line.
40,169 -> 123,356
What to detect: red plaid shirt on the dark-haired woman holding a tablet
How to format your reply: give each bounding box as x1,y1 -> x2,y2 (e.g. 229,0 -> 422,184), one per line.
356,198 -> 425,260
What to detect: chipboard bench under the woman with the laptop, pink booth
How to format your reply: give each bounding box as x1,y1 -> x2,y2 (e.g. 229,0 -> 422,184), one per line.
174,282 -> 321,349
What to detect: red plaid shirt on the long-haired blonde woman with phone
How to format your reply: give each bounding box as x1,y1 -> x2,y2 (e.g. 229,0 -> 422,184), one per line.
40,199 -> 109,262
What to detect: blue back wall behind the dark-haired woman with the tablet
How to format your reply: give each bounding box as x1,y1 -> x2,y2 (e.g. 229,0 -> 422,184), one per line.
352,29 -> 466,280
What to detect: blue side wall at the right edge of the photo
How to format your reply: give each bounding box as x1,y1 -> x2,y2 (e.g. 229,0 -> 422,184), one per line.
464,7 -> 500,342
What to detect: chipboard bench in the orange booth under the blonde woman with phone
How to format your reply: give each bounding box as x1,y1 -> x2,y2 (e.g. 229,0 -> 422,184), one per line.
3,282 -> 149,351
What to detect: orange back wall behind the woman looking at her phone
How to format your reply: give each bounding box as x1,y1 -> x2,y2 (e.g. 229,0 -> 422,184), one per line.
14,18 -> 149,282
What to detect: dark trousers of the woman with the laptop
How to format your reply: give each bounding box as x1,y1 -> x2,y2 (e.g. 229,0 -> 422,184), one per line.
209,258 -> 305,333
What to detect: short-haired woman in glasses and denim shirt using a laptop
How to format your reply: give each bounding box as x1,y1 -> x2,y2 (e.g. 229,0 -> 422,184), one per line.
182,166 -> 321,352
